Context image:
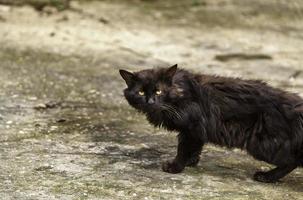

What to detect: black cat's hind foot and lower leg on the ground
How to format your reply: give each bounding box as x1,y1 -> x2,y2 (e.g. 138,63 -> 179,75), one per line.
254,164 -> 297,183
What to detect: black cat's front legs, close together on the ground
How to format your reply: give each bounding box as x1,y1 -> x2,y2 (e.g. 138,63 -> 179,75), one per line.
162,133 -> 203,173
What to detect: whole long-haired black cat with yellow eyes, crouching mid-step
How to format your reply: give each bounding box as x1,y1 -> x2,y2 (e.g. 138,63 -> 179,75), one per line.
120,65 -> 303,182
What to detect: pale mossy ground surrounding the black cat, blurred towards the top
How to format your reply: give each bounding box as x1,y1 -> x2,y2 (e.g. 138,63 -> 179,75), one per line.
0,0 -> 303,200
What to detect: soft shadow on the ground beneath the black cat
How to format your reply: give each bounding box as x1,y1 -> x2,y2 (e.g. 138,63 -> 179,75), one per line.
101,141 -> 303,192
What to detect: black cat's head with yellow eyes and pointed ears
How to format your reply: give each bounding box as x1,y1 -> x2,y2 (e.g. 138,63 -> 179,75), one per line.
120,65 -> 185,113
